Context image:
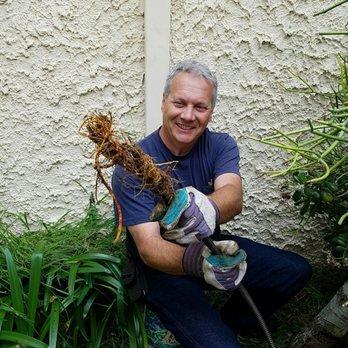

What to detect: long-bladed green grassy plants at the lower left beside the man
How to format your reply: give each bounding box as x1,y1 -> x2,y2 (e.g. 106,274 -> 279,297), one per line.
0,204 -> 147,347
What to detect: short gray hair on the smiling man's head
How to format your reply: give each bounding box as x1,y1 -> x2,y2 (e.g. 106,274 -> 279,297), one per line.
163,60 -> 218,108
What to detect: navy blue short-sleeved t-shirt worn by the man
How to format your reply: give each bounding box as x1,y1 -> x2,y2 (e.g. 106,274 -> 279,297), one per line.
112,129 -> 239,226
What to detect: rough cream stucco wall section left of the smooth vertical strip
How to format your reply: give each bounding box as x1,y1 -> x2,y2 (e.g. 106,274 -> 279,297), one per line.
0,0 -> 145,220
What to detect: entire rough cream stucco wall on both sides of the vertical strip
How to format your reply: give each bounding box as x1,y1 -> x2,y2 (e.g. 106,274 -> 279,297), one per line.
0,0 -> 347,260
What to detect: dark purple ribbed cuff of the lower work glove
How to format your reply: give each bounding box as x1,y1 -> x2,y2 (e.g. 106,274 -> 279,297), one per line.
182,242 -> 204,278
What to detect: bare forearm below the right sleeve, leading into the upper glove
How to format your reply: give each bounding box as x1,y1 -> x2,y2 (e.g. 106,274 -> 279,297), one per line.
209,173 -> 243,224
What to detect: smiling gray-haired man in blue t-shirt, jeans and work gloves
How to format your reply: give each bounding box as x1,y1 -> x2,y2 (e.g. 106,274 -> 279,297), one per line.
112,61 -> 311,348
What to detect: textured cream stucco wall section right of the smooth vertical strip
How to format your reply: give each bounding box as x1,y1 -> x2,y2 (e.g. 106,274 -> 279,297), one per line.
171,0 -> 348,256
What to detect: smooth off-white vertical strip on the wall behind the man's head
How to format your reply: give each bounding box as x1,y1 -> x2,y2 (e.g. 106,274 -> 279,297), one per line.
145,0 -> 170,134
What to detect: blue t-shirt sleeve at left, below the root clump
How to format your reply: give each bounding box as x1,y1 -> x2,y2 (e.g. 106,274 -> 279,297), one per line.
112,165 -> 156,227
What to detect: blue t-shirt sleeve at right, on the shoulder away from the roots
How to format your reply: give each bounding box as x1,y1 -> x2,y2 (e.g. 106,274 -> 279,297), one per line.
214,133 -> 240,179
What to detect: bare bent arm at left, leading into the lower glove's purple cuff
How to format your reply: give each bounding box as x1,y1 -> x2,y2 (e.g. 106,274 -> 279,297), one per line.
128,222 -> 185,275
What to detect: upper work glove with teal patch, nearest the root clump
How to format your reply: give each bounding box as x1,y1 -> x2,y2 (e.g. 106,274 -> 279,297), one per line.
160,186 -> 219,244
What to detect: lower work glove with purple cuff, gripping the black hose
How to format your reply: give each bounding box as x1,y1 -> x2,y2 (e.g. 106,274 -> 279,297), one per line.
182,240 -> 247,290
